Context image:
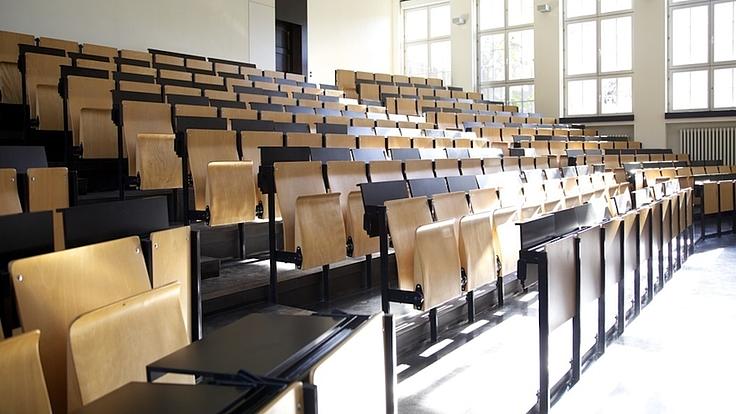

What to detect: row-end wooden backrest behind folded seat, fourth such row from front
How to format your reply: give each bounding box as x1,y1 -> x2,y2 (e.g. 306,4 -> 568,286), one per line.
122,101 -> 174,171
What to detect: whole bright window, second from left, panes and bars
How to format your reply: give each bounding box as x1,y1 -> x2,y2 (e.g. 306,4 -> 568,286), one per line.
478,0 -> 534,112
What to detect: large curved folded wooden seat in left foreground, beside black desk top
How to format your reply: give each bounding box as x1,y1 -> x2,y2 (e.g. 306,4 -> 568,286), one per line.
69,283 -> 189,404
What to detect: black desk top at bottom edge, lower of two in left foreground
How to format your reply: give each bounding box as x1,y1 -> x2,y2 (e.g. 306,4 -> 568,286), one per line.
77,382 -> 249,414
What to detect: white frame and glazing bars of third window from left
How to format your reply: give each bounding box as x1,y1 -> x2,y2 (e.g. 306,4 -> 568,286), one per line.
562,0 -> 636,118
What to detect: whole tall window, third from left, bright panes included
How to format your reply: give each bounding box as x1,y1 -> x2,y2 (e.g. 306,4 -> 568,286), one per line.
564,0 -> 633,116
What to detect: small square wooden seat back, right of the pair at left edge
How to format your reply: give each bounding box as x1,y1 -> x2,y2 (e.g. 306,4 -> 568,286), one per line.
27,167 -> 69,212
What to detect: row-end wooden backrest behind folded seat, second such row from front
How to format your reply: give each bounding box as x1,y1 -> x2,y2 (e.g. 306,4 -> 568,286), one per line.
274,161 -> 326,253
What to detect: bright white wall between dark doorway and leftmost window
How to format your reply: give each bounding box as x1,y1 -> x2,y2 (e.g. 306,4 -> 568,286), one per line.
307,0 -> 398,84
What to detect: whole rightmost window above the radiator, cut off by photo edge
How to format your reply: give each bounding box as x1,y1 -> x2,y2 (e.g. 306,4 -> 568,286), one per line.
668,0 -> 736,111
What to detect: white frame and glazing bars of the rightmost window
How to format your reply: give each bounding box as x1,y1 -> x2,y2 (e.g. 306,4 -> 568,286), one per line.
667,0 -> 736,113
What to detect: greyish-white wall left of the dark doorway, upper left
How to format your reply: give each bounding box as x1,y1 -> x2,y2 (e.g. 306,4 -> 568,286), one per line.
0,0 -> 275,65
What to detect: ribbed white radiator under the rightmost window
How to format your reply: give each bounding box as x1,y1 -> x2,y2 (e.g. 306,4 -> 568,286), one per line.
680,127 -> 736,165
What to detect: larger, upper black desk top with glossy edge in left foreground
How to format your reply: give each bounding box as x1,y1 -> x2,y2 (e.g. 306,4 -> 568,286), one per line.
148,313 -> 346,378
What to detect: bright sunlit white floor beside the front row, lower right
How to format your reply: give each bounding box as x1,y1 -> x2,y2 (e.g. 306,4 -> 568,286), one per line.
552,236 -> 736,414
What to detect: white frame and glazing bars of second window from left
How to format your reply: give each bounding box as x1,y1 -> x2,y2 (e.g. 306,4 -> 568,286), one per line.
475,0 -> 536,111
